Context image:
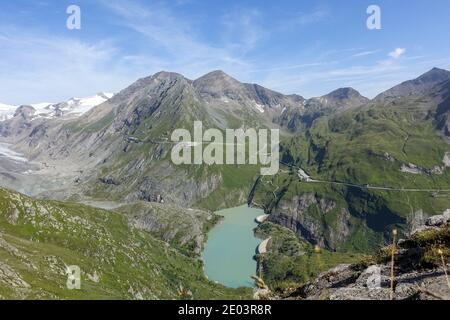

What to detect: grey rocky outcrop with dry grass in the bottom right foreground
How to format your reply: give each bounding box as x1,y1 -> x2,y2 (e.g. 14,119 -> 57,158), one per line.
288,210 -> 450,300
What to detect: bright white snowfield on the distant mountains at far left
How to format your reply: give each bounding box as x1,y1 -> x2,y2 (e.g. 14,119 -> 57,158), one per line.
0,92 -> 114,121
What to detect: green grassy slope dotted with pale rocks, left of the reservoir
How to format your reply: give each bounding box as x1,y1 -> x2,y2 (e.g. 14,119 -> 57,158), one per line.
0,189 -> 249,299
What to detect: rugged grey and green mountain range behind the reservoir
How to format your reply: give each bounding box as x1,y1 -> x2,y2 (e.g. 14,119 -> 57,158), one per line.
0,68 -> 450,298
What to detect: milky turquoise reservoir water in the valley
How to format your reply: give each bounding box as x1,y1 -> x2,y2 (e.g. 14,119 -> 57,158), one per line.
203,205 -> 264,288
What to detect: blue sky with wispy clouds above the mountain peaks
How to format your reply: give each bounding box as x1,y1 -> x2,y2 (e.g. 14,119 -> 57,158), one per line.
0,0 -> 450,104
